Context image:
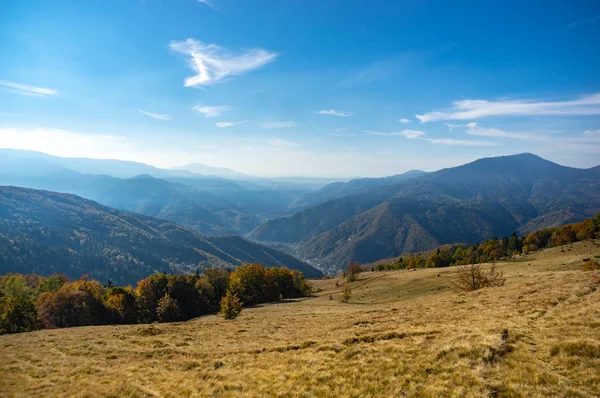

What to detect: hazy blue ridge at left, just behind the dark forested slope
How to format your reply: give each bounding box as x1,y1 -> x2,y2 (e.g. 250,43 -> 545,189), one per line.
0,160 -> 260,235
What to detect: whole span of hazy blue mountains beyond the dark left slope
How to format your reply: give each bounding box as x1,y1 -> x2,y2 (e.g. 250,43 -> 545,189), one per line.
0,149 -> 600,272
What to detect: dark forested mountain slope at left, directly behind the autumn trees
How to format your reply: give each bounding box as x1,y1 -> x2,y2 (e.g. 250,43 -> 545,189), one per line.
0,187 -> 321,284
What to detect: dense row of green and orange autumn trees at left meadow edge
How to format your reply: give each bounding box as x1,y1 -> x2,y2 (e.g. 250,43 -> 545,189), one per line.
0,264 -> 311,334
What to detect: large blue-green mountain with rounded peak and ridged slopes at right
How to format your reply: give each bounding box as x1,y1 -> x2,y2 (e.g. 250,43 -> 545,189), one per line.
250,154 -> 600,269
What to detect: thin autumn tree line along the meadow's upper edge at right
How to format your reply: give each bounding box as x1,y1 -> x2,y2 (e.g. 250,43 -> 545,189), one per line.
372,213 -> 600,271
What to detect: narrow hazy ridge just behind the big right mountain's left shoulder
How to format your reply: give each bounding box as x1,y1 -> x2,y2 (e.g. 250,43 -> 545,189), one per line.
290,170 -> 426,210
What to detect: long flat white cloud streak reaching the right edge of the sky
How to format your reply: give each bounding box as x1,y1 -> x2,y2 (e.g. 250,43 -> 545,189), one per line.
416,94 -> 600,123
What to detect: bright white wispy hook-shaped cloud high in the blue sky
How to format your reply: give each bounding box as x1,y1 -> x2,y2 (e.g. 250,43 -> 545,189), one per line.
170,39 -> 278,87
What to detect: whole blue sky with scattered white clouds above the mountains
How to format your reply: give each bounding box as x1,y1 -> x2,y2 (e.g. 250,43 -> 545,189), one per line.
0,0 -> 600,177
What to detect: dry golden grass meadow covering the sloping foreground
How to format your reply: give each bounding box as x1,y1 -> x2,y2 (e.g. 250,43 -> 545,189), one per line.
0,241 -> 600,397
